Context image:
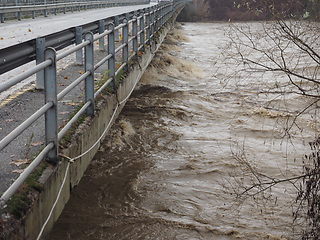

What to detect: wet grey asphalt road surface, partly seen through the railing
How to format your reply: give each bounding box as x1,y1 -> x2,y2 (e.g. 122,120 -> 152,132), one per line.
0,2 -> 155,194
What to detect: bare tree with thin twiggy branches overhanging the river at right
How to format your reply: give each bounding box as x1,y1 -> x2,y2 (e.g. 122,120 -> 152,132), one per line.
225,1 -> 320,239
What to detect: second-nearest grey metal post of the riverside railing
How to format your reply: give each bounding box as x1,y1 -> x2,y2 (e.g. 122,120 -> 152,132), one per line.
85,32 -> 94,116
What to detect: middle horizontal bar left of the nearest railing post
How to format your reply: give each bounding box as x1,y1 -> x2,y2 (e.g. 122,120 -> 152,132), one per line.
0,102 -> 53,151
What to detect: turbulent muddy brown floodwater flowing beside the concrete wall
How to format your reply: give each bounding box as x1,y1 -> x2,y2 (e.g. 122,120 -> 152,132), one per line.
47,23 -> 314,240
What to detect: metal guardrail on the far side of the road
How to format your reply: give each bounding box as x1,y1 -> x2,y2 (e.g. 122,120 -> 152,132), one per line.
0,0 -> 149,23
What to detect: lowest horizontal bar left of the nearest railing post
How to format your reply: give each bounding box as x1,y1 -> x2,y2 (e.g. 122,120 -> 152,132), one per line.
0,142 -> 54,202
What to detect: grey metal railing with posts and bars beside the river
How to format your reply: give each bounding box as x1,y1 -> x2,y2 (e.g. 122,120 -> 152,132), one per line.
0,0 -> 186,203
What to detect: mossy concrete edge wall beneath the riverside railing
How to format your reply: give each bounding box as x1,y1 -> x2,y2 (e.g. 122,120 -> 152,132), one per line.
16,17 -> 180,240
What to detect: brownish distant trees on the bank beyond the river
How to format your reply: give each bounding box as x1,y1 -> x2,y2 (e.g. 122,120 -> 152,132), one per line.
178,0 -> 320,21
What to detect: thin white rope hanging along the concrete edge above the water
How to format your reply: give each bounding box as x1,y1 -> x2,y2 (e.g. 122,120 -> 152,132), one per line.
37,39 -> 164,240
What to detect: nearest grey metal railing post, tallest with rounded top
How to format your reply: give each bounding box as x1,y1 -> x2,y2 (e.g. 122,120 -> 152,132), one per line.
44,48 -> 58,164
